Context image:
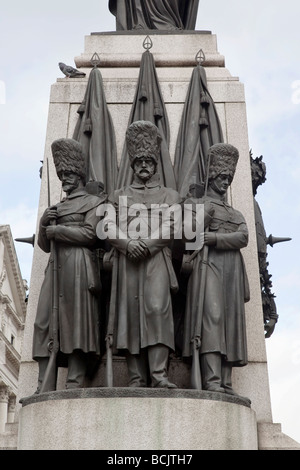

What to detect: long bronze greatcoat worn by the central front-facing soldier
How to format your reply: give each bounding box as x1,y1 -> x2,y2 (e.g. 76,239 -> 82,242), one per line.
105,175 -> 181,354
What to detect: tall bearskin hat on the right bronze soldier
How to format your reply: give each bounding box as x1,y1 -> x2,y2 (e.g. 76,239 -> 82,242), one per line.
208,143 -> 239,181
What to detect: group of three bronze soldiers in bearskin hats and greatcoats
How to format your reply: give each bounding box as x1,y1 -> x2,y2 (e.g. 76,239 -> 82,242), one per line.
33,121 -> 249,394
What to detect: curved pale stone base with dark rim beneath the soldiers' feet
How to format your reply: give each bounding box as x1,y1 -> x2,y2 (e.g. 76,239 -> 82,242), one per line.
18,388 -> 258,450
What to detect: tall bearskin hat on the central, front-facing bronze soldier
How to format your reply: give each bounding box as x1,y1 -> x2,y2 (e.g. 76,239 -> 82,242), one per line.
126,121 -> 162,167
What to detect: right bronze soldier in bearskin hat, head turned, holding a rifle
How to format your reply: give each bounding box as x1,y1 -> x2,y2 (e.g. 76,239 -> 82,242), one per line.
183,144 -> 249,394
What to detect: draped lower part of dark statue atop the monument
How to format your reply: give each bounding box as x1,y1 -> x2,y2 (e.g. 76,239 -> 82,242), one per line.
109,0 -> 199,31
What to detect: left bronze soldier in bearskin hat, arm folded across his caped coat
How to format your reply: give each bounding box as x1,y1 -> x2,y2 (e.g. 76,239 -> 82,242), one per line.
33,139 -> 106,393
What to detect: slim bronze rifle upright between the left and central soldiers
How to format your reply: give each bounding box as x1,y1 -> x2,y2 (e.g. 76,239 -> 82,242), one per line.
105,248 -> 119,387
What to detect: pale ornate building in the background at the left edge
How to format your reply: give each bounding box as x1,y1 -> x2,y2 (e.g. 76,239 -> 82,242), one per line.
0,225 -> 27,448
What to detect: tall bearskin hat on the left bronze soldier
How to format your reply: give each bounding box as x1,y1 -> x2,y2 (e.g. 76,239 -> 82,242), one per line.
51,139 -> 86,183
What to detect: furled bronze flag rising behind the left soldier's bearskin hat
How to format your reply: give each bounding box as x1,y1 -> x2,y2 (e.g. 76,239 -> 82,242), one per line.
73,68 -> 118,193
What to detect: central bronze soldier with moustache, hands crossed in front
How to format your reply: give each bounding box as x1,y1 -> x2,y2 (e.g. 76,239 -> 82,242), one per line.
104,121 -> 181,388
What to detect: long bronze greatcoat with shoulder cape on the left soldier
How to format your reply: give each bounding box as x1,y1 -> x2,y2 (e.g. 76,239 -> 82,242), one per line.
33,190 -> 105,365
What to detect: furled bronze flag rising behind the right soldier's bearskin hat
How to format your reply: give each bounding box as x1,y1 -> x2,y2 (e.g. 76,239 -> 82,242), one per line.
174,65 -> 223,197
